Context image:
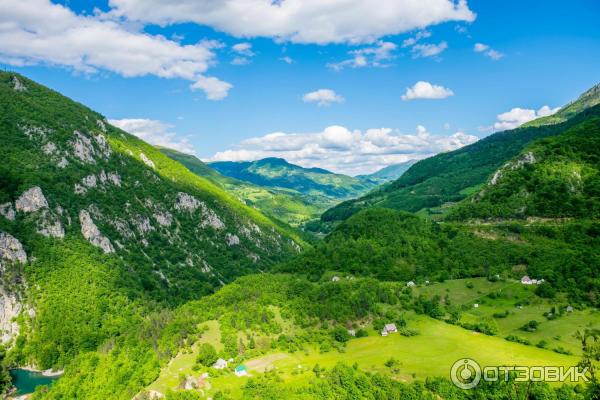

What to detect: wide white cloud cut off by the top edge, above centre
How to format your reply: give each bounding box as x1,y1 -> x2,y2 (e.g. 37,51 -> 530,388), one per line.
109,0 -> 475,44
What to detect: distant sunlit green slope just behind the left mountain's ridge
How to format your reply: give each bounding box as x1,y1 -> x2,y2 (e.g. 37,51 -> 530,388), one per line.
160,148 -> 324,226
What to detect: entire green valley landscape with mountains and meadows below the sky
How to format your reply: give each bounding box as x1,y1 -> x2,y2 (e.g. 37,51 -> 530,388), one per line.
0,40 -> 600,400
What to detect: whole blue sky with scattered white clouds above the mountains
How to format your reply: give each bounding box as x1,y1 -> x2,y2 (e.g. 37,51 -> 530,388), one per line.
0,0 -> 600,174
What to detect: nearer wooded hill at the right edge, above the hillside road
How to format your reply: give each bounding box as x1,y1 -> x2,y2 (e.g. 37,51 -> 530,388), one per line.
450,111 -> 600,219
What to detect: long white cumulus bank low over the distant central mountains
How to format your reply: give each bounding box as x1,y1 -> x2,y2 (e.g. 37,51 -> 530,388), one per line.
208,125 -> 478,175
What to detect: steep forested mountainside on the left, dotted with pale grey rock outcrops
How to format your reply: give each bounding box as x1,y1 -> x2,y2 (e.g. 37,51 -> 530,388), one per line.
0,72 -> 303,378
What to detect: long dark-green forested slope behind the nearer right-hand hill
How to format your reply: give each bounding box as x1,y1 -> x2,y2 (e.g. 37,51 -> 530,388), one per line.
321,83 -> 600,230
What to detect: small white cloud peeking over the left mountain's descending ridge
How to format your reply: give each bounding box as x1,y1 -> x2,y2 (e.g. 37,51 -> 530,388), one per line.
108,118 -> 194,154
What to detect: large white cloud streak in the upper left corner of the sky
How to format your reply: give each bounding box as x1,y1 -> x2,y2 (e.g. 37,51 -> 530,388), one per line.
0,0 -> 232,100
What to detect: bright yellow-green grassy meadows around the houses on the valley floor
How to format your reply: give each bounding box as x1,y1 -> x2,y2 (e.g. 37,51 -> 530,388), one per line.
148,278 -> 600,398
